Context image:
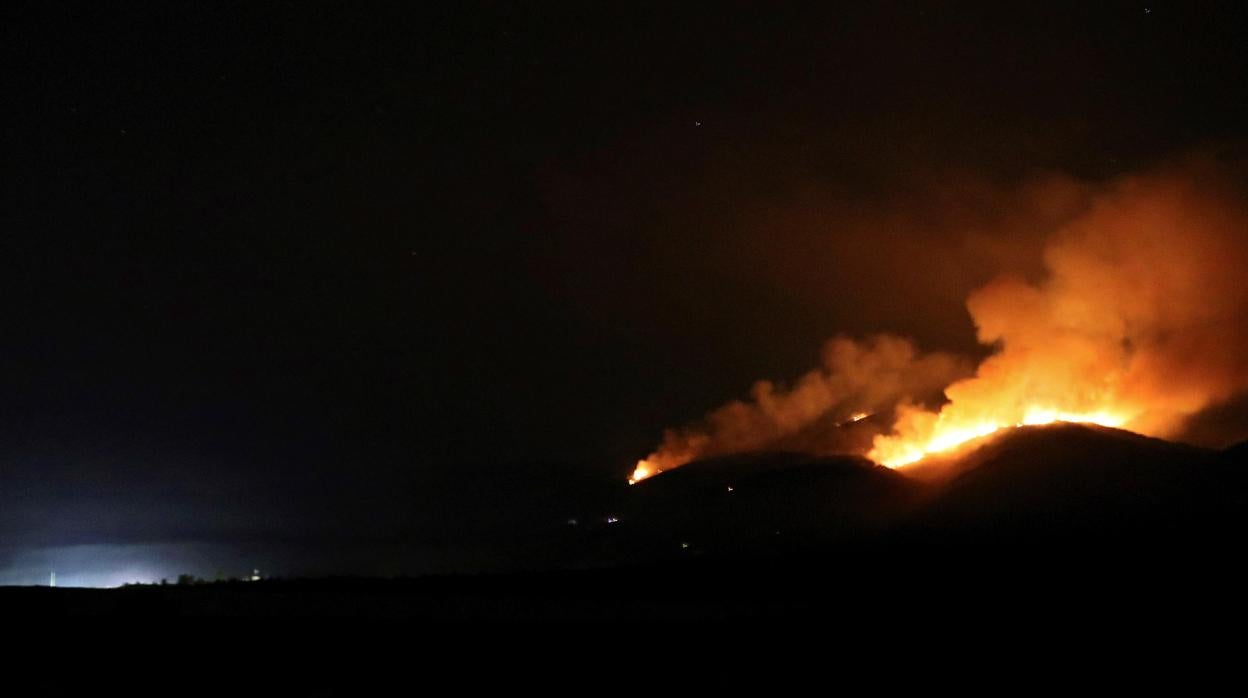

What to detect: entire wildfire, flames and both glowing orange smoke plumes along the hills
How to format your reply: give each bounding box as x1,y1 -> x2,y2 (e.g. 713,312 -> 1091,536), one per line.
630,164 -> 1248,482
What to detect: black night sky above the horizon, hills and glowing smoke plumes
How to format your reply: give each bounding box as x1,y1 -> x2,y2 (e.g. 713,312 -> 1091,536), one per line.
0,1 -> 1248,579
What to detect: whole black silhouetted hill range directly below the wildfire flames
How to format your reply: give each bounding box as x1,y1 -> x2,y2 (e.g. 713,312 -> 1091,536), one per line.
622,423 -> 1248,554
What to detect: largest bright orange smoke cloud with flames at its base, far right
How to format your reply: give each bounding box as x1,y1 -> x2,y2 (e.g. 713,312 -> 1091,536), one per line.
871,165 -> 1248,465
